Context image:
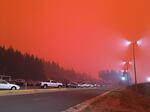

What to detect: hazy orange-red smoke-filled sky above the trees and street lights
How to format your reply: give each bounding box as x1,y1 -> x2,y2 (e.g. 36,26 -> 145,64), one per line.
0,0 -> 150,81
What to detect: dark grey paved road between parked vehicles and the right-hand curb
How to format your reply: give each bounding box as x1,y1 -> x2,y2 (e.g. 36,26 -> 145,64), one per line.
0,89 -> 104,112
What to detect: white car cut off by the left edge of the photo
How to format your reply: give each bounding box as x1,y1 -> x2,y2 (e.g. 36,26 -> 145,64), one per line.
0,80 -> 20,90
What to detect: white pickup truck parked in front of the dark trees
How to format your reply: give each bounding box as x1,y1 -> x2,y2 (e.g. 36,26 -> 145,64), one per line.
40,80 -> 63,89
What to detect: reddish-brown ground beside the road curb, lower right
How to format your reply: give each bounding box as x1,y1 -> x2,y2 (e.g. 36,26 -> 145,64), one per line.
82,90 -> 150,112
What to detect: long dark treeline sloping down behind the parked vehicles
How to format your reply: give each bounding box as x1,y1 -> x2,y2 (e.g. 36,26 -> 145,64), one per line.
0,47 -> 93,82
